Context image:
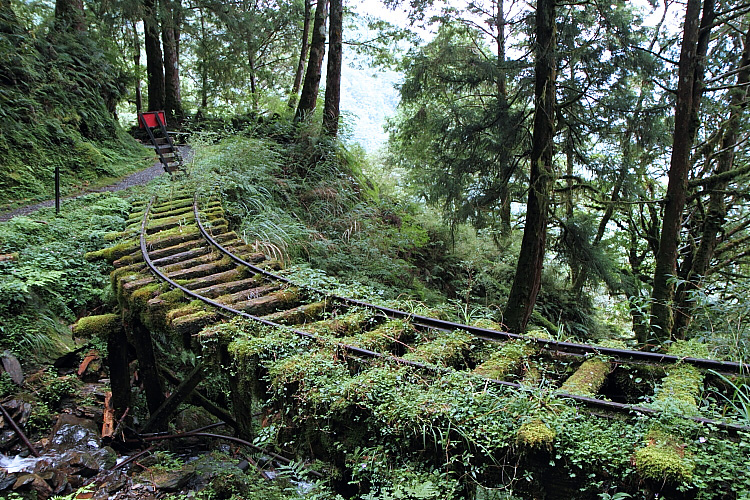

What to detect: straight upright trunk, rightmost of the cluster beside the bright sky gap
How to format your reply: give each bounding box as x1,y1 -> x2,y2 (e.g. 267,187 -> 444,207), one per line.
323,0 -> 344,138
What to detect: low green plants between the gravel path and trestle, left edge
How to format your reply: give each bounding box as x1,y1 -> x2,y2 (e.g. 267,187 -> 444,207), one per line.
0,193 -> 130,356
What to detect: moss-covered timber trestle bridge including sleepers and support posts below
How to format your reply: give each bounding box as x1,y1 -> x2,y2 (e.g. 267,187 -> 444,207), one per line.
79,192 -> 750,498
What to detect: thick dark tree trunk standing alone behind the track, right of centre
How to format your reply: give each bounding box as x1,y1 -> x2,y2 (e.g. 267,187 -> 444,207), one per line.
503,0 -> 557,333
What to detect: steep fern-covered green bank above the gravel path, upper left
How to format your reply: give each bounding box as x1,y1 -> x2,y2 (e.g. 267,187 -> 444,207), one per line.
0,13 -> 153,209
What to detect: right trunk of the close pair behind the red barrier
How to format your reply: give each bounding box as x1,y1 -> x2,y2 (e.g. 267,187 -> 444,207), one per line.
161,0 -> 184,123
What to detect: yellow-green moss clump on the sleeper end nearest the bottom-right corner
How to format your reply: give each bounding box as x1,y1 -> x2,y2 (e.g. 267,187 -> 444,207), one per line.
633,431 -> 695,483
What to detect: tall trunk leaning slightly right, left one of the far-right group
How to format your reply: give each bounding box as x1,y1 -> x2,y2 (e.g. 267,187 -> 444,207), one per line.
651,0 -> 714,342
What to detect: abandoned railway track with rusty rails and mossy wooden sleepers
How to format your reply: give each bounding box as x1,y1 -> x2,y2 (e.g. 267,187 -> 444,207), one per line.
79,189 -> 746,431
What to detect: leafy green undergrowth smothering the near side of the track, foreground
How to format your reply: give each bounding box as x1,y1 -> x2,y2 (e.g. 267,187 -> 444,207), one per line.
197,320 -> 750,499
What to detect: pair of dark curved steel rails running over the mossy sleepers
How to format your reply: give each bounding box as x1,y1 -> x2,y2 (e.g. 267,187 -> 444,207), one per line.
140,193 -> 750,432
